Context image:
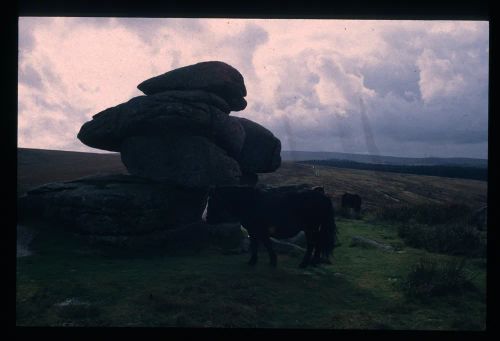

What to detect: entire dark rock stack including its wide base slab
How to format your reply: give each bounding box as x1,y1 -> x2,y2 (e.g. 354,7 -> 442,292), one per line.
21,61 -> 281,247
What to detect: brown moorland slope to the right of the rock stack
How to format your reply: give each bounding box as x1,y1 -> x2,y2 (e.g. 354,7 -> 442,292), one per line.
259,162 -> 488,209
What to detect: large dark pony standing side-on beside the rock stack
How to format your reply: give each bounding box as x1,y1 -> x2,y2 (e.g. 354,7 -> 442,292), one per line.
206,186 -> 337,267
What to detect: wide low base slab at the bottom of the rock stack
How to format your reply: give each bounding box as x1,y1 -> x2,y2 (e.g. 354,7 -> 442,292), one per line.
18,175 -> 207,238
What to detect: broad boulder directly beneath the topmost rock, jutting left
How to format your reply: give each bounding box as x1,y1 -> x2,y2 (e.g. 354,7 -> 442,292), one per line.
77,91 -> 245,155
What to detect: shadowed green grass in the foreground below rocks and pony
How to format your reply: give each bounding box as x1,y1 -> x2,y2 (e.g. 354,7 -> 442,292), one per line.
16,219 -> 486,330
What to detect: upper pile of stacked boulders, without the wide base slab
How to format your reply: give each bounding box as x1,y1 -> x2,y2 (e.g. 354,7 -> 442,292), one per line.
78,62 -> 281,187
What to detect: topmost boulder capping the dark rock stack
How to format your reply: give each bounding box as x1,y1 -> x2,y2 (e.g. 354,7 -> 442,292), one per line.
137,61 -> 247,111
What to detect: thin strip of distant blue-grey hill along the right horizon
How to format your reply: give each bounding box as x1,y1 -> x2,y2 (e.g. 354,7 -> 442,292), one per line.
281,150 -> 488,168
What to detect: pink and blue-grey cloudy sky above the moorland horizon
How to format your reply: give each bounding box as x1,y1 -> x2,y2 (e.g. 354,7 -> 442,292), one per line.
18,17 -> 489,158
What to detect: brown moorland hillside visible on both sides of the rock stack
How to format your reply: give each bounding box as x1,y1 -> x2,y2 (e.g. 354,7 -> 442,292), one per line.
17,148 -> 487,208
